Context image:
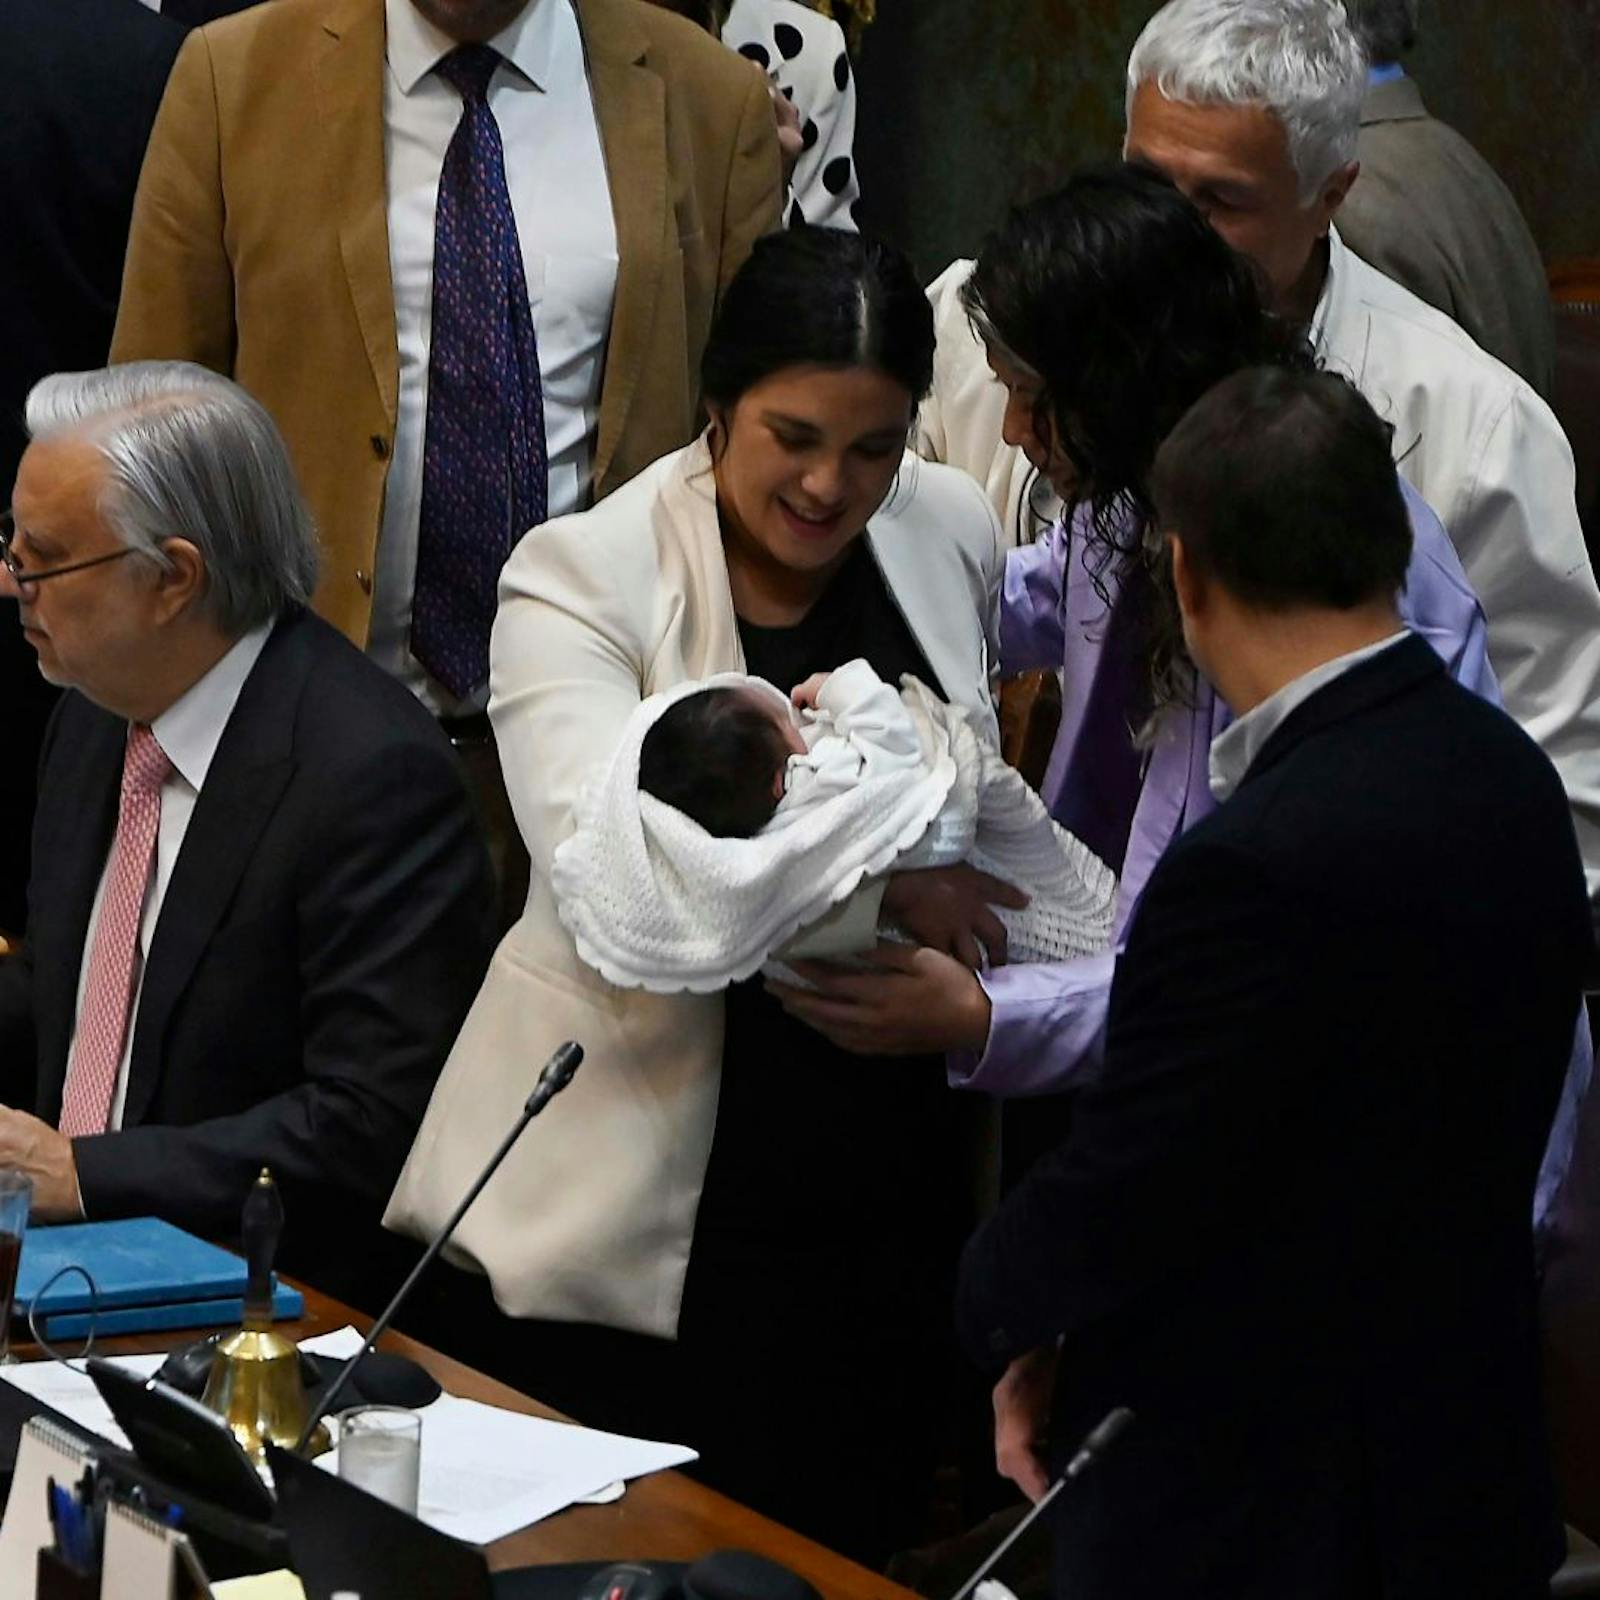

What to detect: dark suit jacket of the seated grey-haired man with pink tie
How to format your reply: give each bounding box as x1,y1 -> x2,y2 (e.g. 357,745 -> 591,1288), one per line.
0,614 -> 490,1285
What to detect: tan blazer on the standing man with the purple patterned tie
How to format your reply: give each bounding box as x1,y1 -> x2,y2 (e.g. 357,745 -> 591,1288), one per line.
112,0 -> 779,645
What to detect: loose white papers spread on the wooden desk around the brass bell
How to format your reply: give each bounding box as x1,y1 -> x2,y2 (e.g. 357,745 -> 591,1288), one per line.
0,1328 -> 696,1544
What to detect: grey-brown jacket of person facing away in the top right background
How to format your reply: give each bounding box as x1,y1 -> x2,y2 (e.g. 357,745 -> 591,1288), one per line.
1339,78 -> 1555,400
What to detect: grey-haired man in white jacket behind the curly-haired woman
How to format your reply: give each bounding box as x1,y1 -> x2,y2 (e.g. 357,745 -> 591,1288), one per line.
923,0 -> 1600,934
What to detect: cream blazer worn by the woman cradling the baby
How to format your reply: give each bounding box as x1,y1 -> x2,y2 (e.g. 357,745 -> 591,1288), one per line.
384,442 -> 1003,1338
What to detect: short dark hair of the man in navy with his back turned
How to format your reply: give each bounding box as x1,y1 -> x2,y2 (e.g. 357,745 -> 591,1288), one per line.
1152,366 -> 1411,611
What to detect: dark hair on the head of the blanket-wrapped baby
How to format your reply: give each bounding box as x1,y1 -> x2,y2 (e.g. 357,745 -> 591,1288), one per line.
638,688 -> 790,838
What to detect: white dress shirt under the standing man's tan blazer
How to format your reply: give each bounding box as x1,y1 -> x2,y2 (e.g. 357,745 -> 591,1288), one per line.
368,0 -> 618,715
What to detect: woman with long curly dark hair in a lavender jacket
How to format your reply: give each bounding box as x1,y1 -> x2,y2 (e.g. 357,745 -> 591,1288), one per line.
784,166 -> 1498,1094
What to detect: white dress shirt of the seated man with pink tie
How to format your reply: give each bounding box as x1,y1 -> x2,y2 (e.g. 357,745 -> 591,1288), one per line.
67,622 -> 272,1130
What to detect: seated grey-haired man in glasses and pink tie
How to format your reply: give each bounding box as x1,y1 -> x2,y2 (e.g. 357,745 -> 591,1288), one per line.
0,362 -> 490,1286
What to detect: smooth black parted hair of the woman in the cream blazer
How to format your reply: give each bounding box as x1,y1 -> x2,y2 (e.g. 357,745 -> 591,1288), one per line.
701,226 -> 933,408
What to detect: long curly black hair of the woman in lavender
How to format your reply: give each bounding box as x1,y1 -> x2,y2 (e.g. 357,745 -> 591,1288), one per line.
962,163 -> 1315,707
